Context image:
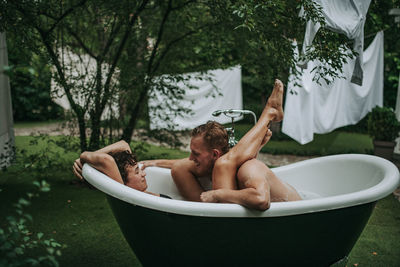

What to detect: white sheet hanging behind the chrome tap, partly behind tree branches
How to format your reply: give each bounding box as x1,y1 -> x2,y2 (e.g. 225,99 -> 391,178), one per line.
148,66 -> 243,130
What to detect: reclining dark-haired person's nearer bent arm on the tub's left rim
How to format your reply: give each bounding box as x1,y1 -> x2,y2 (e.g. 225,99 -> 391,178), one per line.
79,151 -> 123,184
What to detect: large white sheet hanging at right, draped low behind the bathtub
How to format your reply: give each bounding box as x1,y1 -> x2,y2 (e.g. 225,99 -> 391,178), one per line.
282,32 -> 384,144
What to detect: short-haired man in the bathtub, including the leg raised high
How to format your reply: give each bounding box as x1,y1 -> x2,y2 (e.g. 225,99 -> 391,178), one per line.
143,80 -> 301,210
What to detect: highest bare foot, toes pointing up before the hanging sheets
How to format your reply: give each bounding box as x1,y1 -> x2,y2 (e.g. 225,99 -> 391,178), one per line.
264,79 -> 283,122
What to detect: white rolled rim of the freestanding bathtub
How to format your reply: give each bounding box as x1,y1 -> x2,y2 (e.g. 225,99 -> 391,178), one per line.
82,154 -> 399,218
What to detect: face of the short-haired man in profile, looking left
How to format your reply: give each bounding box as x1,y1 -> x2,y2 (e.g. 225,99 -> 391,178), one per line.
189,135 -> 216,173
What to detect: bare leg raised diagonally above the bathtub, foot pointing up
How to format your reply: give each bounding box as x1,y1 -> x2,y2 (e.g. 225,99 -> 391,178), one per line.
212,79 -> 283,189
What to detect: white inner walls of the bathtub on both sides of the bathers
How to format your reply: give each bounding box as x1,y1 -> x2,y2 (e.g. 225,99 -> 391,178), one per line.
146,159 -> 385,199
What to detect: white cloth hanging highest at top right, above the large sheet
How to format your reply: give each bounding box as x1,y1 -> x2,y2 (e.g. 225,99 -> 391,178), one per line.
299,0 -> 371,85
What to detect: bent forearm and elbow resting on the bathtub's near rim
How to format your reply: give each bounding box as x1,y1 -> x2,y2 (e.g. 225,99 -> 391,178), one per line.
200,179 -> 271,211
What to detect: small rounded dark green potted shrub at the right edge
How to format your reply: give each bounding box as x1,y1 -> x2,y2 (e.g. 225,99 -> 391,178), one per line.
368,107 -> 400,141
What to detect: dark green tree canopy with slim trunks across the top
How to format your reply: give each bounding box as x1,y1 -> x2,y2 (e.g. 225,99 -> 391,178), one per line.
0,0 -> 398,150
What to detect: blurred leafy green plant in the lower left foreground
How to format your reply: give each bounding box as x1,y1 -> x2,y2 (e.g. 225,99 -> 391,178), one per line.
0,135 -> 76,266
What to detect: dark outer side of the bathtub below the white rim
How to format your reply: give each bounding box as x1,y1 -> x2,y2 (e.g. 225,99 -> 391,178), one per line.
107,195 -> 376,267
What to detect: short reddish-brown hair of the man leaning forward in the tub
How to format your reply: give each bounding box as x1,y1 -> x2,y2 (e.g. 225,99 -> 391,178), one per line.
191,121 -> 229,154
